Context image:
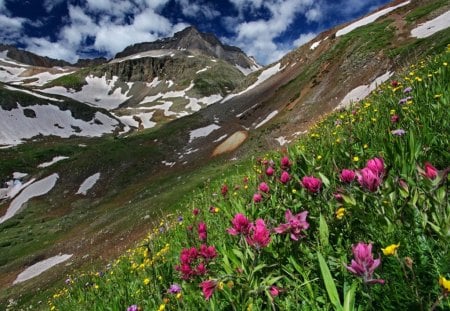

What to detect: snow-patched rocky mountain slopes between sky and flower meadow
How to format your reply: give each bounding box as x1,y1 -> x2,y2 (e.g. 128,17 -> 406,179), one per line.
0,0 -> 450,306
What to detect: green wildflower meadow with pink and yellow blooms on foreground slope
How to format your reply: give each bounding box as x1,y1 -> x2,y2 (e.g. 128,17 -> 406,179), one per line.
48,46 -> 450,311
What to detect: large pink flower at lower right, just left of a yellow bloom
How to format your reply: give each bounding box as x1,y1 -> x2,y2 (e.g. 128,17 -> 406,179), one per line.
346,242 -> 384,284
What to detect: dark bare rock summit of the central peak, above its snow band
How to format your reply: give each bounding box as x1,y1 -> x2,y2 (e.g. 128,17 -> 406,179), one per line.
115,27 -> 255,68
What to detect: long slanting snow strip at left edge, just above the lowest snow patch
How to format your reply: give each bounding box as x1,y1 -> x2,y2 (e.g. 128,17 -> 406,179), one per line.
0,173 -> 59,224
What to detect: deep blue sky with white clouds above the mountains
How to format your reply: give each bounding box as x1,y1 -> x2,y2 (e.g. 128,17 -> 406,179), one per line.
0,0 -> 390,65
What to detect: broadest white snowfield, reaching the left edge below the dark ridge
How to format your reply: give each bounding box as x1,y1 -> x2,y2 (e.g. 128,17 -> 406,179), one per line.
0,104 -> 119,145
